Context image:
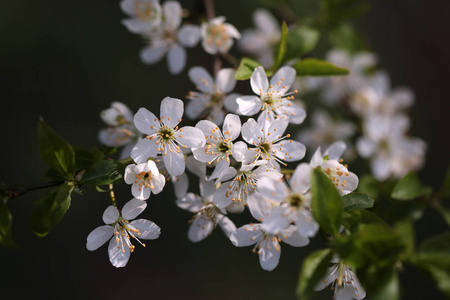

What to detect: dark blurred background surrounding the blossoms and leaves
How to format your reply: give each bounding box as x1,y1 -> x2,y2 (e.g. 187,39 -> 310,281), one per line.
0,0 -> 450,299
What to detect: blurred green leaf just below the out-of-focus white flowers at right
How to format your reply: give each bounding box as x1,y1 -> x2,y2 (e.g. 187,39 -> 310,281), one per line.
391,172 -> 431,200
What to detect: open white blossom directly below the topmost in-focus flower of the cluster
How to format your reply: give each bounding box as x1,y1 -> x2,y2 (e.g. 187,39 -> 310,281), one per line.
241,117 -> 306,169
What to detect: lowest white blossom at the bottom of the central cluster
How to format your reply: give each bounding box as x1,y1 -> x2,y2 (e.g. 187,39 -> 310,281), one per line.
230,194 -> 309,271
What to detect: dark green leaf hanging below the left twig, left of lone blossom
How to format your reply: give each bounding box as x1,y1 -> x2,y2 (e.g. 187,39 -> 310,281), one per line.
31,183 -> 75,237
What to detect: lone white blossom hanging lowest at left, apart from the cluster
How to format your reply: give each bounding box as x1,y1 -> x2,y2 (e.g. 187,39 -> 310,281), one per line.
86,199 -> 161,268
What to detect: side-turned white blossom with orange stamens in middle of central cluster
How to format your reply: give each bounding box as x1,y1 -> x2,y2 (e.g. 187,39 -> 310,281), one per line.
213,160 -> 283,211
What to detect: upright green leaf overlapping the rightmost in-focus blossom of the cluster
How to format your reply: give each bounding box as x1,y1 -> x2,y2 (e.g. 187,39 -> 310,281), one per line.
311,168 -> 344,236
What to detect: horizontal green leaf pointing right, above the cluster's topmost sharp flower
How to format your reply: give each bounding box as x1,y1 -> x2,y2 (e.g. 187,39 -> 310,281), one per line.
294,58 -> 348,76
